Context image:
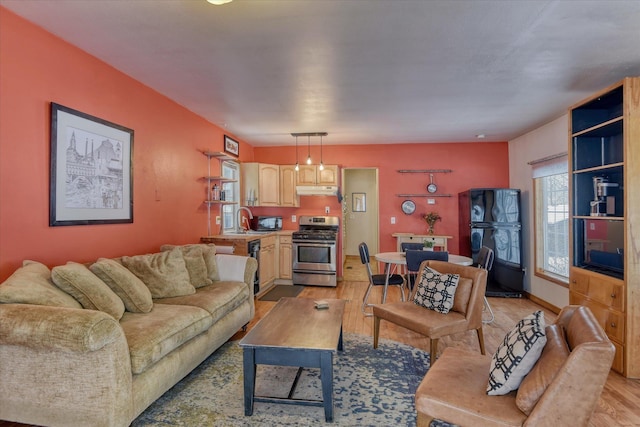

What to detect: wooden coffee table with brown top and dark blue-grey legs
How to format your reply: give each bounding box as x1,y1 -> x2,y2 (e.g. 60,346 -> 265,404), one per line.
240,298 -> 346,422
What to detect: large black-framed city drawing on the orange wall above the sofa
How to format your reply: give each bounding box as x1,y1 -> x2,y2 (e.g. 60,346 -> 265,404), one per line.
49,102 -> 133,226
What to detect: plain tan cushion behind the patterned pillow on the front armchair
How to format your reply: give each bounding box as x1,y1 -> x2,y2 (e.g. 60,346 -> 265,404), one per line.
516,324 -> 570,415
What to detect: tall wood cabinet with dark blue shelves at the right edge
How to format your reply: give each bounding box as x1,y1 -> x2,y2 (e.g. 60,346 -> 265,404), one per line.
569,77 -> 640,378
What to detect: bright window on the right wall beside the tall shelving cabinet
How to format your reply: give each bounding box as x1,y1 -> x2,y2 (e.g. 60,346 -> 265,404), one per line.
533,166 -> 569,286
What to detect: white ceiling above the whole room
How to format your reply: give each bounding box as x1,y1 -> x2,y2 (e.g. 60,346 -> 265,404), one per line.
0,0 -> 640,146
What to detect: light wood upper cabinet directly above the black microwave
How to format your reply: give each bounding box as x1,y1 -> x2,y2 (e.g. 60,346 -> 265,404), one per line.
241,163 -> 280,206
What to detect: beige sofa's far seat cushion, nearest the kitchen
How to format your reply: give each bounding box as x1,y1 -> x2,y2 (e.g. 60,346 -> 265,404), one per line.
155,281 -> 253,322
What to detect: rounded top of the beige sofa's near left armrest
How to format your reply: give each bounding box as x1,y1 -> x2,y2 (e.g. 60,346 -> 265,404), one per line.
0,304 -> 124,353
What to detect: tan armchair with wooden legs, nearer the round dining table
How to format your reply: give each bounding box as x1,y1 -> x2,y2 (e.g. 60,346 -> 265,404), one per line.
373,261 -> 487,366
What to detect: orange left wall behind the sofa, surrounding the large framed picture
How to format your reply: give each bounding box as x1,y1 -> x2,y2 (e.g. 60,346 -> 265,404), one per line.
0,7 -> 253,280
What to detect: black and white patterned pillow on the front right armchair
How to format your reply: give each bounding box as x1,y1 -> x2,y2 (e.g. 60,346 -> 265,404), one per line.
487,310 -> 547,396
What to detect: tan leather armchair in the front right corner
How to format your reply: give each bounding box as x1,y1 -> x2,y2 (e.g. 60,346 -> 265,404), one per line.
416,306 -> 615,427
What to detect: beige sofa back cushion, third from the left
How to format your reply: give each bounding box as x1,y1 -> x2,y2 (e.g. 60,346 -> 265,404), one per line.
89,258 -> 153,313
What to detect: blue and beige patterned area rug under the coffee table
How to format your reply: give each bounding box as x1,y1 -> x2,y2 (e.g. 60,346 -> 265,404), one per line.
132,334 -> 446,427
